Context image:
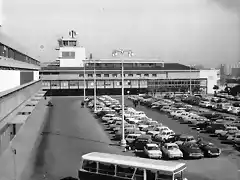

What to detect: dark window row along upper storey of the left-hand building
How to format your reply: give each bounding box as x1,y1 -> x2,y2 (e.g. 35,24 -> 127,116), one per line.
0,43 -> 40,66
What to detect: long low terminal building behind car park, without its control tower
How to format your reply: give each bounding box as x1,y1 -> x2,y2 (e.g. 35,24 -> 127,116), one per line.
40,59 -> 219,93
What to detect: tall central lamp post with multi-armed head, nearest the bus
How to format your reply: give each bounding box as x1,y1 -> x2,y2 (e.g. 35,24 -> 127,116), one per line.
112,49 -> 133,147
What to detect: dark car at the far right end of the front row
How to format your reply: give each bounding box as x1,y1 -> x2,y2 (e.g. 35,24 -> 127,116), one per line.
198,141 -> 221,157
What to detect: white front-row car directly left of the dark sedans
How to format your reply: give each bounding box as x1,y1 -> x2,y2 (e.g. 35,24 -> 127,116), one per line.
162,143 -> 183,159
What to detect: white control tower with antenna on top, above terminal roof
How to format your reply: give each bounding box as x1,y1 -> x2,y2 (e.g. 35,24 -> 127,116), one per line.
56,30 -> 86,67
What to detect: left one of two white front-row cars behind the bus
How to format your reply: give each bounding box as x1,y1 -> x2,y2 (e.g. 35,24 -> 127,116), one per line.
143,143 -> 162,159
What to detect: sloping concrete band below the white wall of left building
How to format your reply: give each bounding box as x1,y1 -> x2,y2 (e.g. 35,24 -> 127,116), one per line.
0,81 -> 42,121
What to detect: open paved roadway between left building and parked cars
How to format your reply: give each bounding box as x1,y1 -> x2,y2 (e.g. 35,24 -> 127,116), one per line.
31,97 -> 129,180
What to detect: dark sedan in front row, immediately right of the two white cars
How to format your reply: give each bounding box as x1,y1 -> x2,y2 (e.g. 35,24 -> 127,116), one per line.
179,142 -> 204,159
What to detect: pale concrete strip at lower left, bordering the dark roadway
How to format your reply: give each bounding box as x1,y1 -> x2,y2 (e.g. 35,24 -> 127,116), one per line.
0,99 -> 49,180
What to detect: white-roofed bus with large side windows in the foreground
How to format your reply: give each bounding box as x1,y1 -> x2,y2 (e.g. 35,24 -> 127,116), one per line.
78,152 -> 187,180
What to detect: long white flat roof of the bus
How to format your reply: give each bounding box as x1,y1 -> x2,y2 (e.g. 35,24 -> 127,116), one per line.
82,152 -> 187,174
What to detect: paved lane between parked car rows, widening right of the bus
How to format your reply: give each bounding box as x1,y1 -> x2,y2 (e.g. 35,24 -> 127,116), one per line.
122,98 -> 240,180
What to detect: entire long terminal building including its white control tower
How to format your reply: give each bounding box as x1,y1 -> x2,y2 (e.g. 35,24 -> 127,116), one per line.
40,33 -> 220,94
